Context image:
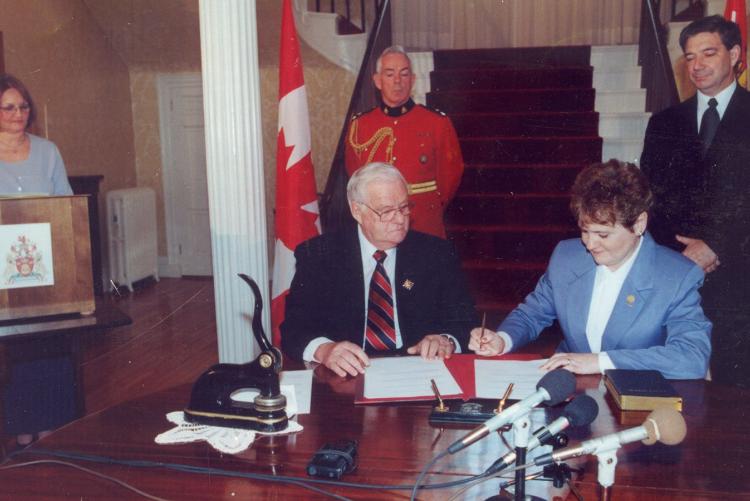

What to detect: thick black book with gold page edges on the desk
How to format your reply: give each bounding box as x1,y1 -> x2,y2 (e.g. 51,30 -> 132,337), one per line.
604,369 -> 682,411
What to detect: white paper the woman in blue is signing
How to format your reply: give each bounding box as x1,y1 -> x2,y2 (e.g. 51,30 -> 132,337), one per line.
474,359 -> 547,400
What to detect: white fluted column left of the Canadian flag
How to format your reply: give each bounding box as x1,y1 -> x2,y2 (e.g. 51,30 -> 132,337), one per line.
200,0 -> 270,363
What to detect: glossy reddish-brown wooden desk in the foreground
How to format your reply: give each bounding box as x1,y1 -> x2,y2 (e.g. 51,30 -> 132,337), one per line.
0,362 -> 750,501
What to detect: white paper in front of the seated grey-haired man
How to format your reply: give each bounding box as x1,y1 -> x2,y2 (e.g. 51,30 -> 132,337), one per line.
363,357 -> 461,399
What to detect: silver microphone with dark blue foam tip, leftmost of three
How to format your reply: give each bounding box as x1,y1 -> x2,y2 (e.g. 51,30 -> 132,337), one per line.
448,369 -> 576,454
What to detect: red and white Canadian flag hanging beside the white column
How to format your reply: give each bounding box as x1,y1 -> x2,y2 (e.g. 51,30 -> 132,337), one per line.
271,0 -> 320,346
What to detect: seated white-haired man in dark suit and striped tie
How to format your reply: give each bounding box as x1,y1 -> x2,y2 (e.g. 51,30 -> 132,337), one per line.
281,163 -> 477,376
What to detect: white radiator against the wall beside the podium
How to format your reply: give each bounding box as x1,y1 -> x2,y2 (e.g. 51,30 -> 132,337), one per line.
107,188 -> 159,292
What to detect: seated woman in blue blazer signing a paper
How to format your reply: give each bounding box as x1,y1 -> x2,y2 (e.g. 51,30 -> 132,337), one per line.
469,160 -> 711,379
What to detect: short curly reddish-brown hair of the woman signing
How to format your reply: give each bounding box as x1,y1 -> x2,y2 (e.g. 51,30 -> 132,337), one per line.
570,159 -> 654,229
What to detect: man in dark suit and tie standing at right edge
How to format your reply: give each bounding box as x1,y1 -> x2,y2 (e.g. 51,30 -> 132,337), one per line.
641,16 -> 750,386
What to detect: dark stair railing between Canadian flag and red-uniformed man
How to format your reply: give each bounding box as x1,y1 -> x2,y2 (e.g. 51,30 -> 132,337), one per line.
320,0 -> 391,232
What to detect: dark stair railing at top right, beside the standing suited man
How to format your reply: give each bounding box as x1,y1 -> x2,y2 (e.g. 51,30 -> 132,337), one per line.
638,0 -> 679,112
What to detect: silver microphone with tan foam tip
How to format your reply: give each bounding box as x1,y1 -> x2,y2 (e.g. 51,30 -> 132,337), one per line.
534,408 -> 687,466
